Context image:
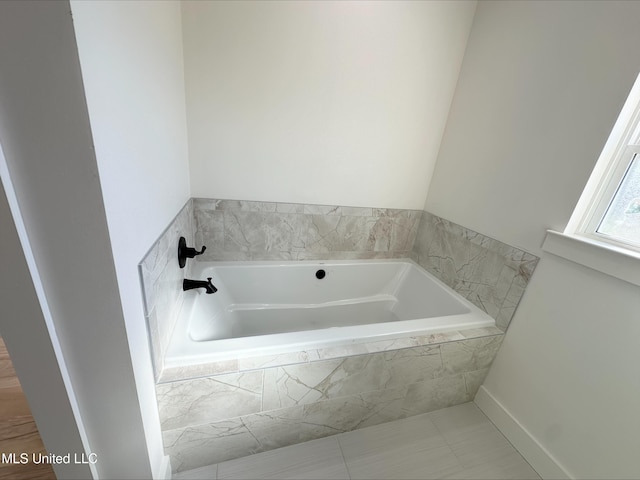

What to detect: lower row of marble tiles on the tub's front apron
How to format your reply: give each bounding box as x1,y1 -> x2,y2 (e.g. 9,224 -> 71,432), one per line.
163,371 -> 486,472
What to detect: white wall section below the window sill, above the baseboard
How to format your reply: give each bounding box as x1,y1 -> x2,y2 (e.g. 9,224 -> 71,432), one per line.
483,255 -> 640,479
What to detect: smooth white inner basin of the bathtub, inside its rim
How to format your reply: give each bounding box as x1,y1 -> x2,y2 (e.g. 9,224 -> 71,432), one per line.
184,261 -> 470,342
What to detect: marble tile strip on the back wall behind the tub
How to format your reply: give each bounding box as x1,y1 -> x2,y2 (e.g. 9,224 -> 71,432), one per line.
193,198 -> 422,261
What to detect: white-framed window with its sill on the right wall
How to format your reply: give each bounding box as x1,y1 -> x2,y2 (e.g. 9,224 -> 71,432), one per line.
542,75 -> 640,286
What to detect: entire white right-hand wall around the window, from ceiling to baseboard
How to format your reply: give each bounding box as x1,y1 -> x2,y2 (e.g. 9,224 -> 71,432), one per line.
426,1 -> 640,478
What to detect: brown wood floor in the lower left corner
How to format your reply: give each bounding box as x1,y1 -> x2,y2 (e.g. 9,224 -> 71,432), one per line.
0,337 -> 56,480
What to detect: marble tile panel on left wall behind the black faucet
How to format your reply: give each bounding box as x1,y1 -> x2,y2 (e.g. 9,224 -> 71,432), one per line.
138,200 -> 194,380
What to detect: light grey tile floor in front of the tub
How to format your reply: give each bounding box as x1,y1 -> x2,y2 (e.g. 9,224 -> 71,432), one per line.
173,403 -> 540,479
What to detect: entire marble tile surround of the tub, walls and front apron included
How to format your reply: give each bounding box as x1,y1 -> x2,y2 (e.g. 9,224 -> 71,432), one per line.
140,199 -> 538,471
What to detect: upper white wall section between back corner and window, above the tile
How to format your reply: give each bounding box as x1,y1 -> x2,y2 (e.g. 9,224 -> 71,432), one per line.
426,1 -> 640,254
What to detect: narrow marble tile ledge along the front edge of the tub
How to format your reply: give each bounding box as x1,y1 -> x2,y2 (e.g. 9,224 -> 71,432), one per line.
158,327 -> 503,384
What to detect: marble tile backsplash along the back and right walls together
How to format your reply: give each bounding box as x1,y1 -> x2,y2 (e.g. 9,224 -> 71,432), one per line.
193,198 -> 538,330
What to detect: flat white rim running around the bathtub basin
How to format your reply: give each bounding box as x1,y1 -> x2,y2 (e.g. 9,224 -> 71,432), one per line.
159,258 -> 502,383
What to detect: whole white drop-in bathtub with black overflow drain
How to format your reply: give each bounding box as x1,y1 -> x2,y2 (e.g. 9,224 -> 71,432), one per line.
164,260 -> 495,368
